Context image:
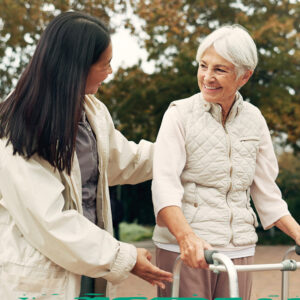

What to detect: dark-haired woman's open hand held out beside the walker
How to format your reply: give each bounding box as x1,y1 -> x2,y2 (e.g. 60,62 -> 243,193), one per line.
131,248 -> 173,289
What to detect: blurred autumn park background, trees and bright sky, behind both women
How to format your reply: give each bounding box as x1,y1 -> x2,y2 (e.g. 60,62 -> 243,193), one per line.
0,0 -> 300,244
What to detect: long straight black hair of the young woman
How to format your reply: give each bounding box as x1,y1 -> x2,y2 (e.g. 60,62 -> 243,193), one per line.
0,12 -> 110,174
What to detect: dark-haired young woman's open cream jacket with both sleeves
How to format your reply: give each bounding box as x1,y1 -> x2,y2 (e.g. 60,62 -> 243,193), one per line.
0,95 -> 153,300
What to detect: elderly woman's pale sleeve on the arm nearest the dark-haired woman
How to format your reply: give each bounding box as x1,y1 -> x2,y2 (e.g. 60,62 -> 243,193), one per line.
152,106 -> 186,220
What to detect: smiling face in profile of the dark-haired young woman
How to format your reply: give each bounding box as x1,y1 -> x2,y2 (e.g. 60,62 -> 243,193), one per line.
85,43 -> 112,94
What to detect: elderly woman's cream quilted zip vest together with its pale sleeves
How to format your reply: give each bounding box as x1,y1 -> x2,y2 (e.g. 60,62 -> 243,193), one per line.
152,93 -> 289,247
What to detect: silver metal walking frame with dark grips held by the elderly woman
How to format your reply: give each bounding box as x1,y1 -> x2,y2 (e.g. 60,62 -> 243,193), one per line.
171,245 -> 300,300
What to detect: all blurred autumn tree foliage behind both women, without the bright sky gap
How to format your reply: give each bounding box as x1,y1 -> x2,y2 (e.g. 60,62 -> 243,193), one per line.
0,0 -> 300,222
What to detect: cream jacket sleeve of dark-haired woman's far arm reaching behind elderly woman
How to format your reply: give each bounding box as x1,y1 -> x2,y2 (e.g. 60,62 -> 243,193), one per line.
105,107 -> 154,186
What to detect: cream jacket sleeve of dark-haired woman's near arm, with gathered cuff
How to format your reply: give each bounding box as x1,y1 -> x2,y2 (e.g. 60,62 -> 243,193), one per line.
0,148 -> 137,283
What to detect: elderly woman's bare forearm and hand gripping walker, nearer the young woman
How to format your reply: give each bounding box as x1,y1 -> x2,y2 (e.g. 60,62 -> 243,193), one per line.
158,206 -> 212,269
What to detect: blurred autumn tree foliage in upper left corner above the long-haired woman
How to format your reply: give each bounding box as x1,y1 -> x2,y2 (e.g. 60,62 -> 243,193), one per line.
0,0 -> 125,99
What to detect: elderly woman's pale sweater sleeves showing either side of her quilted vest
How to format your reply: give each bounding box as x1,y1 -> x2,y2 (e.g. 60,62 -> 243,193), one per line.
152,94 -> 289,253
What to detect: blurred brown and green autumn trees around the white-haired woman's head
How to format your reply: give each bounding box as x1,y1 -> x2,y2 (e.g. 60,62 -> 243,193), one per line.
101,0 -> 300,151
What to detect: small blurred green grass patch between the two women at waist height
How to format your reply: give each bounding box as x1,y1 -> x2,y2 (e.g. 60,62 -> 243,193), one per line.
120,222 -> 154,243
